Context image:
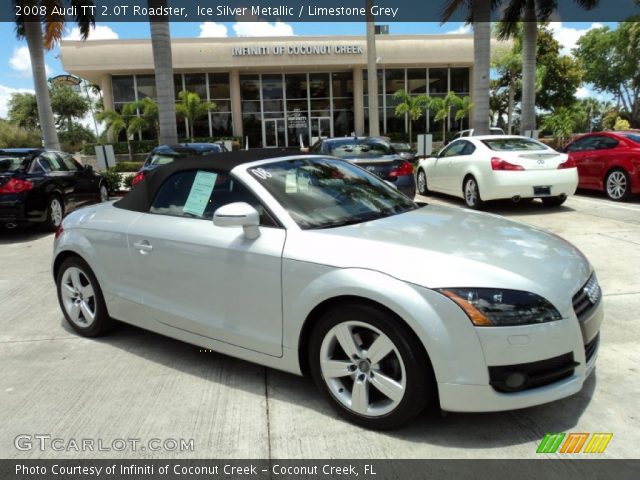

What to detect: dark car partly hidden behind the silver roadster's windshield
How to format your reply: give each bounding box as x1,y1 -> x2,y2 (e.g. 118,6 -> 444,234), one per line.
309,137 -> 416,198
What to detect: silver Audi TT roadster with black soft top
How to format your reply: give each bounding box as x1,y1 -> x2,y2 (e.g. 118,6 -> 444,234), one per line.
52,149 -> 603,429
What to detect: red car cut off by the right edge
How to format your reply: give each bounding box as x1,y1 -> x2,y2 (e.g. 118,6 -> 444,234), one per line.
565,130 -> 640,201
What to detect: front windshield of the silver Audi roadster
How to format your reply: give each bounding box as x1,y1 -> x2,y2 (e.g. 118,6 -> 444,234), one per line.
249,158 -> 418,229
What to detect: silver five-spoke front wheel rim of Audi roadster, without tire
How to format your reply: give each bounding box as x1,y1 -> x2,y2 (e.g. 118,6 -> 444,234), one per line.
320,321 -> 407,417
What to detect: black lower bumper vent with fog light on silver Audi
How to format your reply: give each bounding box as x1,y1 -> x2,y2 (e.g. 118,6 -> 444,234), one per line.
489,353 -> 579,393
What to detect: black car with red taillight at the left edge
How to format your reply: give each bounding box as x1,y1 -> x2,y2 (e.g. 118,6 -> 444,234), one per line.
0,148 -> 109,230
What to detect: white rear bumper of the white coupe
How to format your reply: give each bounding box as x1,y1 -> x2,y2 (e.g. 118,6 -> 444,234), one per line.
480,168 -> 578,200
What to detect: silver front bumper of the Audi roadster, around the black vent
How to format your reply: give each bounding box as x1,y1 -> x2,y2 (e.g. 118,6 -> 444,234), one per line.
438,302 -> 604,412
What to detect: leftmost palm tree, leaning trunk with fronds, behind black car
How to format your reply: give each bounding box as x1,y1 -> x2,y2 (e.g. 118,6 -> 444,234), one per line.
16,0 -> 95,150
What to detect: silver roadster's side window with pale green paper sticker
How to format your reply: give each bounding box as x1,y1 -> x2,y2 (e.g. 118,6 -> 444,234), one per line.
149,170 -> 277,227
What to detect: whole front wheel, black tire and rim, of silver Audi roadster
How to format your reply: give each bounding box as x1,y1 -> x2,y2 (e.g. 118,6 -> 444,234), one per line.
309,304 -> 435,430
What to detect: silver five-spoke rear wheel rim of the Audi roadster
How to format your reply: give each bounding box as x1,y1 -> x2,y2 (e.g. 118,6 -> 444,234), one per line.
60,267 -> 96,328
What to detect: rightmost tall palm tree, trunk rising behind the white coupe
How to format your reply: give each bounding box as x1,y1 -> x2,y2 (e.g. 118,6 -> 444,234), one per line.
498,0 -> 598,132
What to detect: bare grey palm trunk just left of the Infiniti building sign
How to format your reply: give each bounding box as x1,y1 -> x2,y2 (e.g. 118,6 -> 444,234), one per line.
147,0 -> 178,145
